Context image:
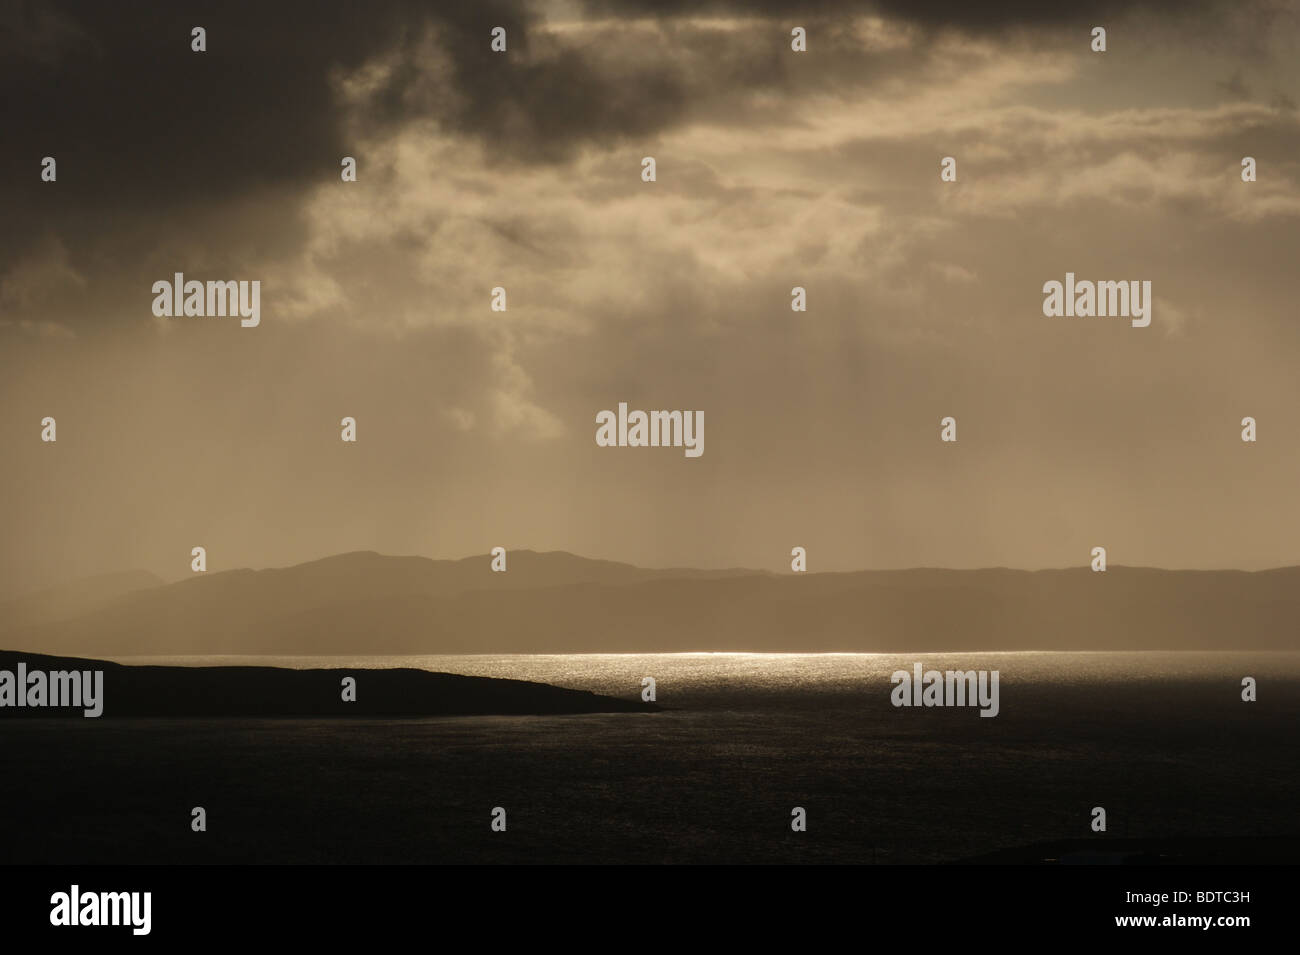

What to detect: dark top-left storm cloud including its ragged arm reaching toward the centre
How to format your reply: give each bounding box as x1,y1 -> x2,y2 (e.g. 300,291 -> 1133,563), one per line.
0,0 -> 691,218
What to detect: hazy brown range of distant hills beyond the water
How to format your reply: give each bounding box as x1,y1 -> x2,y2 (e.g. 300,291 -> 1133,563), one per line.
0,551 -> 1300,655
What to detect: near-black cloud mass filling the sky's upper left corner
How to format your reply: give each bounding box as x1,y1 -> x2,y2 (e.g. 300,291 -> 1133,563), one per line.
0,1 -> 418,322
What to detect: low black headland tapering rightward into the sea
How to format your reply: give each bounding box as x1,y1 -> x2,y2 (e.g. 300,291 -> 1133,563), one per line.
0,650 -> 660,719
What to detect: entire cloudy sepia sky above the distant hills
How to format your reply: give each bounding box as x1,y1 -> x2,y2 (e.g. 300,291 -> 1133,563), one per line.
0,0 -> 1300,592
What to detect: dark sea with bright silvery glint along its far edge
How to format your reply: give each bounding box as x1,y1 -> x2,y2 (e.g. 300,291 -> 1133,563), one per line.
0,654 -> 1300,863
